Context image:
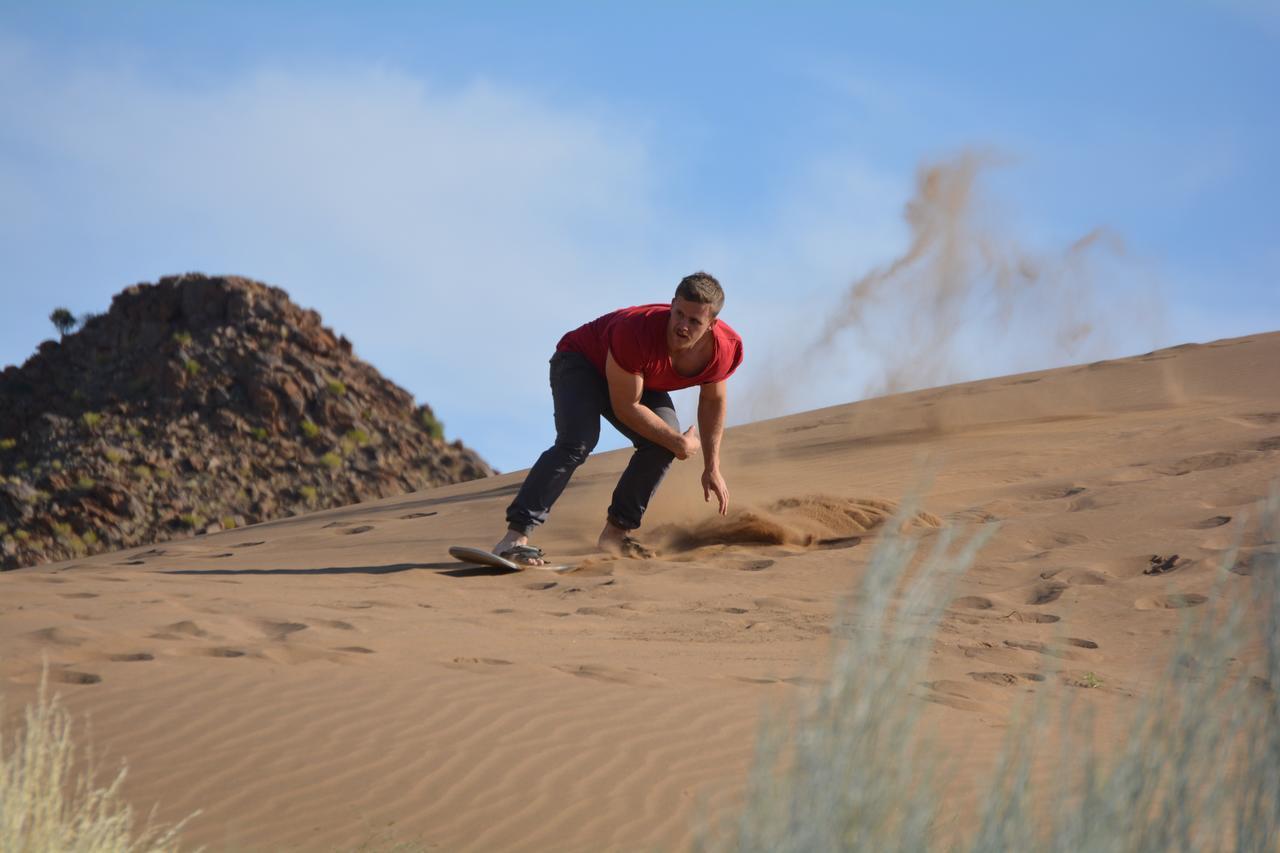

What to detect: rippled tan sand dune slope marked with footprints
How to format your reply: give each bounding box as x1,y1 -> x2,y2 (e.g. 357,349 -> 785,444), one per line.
0,333 -> 1280,850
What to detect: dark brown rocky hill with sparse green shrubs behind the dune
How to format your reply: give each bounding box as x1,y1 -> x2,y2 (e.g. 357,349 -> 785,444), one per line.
0,274 -> 493,569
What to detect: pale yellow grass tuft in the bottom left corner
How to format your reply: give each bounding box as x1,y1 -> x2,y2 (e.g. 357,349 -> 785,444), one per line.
0,672 -> 189,853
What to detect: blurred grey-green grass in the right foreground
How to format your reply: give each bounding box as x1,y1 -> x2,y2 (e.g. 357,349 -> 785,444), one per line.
707,497 -> 1280,853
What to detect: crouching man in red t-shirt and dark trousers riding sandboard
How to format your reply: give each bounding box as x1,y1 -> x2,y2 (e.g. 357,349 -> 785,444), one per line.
493,273 -> 742,566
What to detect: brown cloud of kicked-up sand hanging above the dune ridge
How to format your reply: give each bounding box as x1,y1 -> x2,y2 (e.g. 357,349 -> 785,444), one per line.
745,150 -> 1124,420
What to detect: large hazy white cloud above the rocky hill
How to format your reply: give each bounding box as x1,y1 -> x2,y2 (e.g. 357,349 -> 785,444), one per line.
0,39 -> 669,466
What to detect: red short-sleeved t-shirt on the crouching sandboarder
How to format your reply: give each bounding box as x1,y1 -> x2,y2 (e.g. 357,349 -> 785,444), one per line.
556,305 -> 742,391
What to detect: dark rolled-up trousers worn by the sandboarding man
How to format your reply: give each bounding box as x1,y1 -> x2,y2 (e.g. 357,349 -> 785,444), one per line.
507,352 -> 680,535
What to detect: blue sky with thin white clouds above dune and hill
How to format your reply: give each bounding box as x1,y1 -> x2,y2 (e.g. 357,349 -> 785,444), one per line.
0,0 -> 1280,470
